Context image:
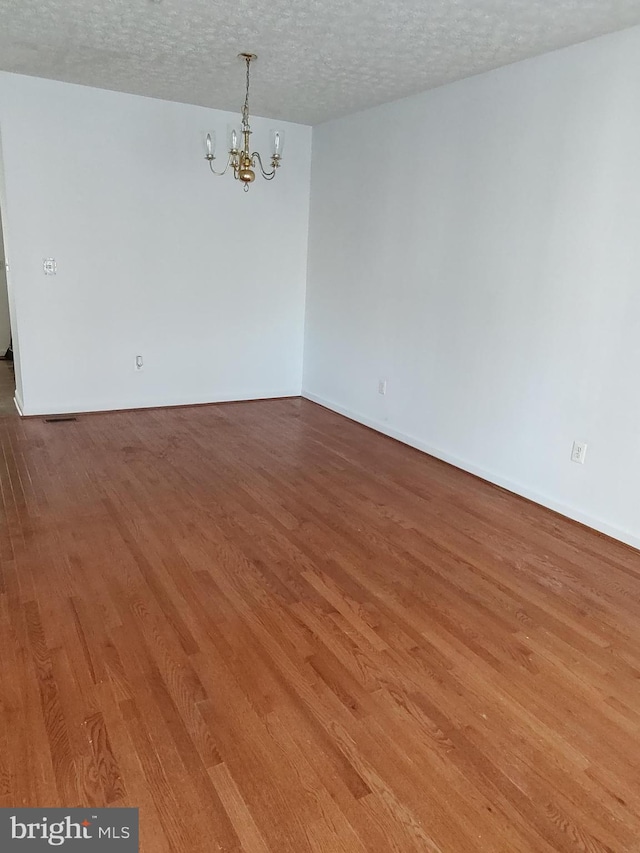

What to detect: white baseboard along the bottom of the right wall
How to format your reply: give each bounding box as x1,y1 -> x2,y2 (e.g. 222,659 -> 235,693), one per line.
302,390 -> 640,550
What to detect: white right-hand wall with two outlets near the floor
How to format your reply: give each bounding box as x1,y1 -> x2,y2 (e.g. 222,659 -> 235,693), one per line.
303,28 -> 640,546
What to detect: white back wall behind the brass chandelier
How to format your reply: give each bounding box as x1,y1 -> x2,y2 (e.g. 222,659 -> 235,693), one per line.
0,74 -> 311,414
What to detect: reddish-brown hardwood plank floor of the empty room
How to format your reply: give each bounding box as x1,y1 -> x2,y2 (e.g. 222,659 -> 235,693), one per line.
0,399 -> 640,853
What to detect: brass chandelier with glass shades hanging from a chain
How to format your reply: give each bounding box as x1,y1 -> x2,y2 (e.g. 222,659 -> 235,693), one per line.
205,53 -> 284,192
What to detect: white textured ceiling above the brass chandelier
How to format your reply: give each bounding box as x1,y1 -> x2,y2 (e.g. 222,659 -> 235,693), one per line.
0,0 -> 640,124
